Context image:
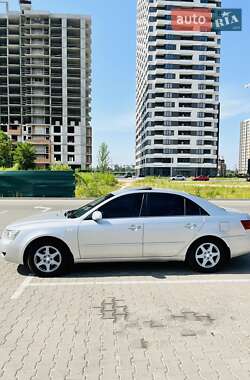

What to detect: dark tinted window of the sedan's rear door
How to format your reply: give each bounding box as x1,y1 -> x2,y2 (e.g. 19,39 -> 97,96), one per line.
143,193 -> 184,216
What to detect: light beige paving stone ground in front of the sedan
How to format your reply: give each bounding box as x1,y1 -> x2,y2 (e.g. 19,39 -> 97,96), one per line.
0,259 -> 250,380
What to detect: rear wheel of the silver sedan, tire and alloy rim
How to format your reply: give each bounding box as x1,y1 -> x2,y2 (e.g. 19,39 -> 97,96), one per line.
186,237 -> 230,273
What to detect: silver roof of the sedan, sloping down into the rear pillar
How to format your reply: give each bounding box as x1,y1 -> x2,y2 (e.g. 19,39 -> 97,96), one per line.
112,187 -> 226,215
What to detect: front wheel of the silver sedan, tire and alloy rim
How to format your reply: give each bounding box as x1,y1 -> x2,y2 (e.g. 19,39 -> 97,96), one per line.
27,239 -> 73,277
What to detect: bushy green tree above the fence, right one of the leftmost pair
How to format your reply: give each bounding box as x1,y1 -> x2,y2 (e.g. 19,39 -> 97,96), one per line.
14,142 -> 36,170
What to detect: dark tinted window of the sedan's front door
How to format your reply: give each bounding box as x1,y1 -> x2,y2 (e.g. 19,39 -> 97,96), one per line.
99,194 -> 142,219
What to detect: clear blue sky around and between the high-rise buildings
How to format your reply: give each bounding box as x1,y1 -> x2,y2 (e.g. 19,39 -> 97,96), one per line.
0,0 -> 250,169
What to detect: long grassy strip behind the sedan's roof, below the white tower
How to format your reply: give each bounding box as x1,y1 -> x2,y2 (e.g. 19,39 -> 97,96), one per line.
131,177 -> 250,199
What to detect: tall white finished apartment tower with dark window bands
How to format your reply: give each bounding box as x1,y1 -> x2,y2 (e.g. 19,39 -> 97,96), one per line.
136,0 -> 221,176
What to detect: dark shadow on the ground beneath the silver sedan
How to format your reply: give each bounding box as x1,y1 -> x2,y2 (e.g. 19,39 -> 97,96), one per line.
17,254 -> 250,279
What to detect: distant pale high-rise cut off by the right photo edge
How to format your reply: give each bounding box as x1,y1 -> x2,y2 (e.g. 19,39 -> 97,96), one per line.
239,119 -> 250,174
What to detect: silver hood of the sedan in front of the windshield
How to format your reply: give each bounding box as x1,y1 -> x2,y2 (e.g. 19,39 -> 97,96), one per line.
8,210 -> 67,229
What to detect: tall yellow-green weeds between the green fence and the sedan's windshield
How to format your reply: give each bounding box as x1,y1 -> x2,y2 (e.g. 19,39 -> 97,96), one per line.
75,173 -> 120,198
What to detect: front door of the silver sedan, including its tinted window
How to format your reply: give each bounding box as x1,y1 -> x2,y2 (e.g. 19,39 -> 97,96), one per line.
78,193 -> 143,259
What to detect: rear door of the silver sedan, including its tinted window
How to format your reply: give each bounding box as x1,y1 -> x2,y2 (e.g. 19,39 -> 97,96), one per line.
142,192 -> 207,257
